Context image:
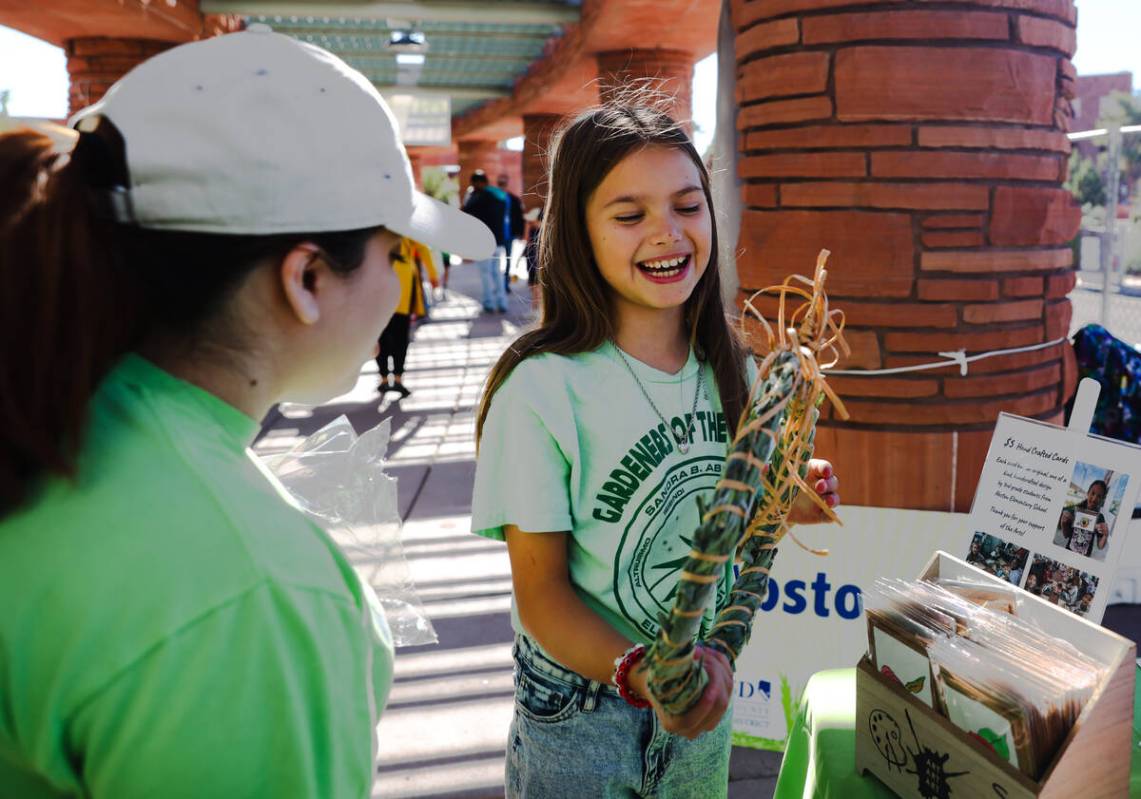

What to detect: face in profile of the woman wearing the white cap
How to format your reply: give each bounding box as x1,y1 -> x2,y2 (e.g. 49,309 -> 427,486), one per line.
289,231 -> 400,403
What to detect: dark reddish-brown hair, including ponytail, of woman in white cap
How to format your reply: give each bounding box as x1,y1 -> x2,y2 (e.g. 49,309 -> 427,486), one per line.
0,120 -> 378,519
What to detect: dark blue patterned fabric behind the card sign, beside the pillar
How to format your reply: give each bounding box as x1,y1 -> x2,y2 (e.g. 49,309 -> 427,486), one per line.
1067,324 -> 1141,444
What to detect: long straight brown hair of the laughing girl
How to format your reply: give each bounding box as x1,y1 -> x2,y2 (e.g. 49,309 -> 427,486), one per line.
476,104 -> 747,443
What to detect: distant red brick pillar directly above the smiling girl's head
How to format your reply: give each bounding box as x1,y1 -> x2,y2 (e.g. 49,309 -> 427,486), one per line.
596,49 -> 694,129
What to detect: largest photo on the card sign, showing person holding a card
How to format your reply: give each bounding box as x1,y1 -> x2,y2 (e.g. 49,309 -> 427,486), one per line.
1054,461 -> 1130,560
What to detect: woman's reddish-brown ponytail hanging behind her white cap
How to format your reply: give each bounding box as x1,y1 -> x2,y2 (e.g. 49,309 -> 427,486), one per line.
0,129 -> 140,517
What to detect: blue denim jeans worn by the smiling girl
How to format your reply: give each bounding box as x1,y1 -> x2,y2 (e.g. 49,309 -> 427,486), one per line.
507,635 -> 731,799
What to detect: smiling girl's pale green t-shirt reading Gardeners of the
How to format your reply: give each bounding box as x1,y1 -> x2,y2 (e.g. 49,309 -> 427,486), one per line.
471,342 -> 731,643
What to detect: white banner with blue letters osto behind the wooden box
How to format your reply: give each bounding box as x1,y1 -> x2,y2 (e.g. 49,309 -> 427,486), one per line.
733,507 -> 972,750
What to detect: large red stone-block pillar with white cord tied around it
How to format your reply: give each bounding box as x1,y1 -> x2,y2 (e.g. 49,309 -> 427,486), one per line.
733,0 -> 1079,511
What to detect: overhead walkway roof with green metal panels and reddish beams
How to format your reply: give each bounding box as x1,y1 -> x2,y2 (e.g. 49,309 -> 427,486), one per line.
0,0 -> 721,147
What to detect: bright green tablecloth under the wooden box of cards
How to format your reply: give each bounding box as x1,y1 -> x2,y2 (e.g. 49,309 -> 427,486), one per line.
774,669 -> 1141,799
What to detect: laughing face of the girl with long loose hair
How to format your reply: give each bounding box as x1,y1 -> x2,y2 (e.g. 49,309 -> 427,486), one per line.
586,146 -> 713,318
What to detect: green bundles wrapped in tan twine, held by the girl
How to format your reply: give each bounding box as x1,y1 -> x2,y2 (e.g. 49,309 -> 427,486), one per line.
646,250 -> 849,715
